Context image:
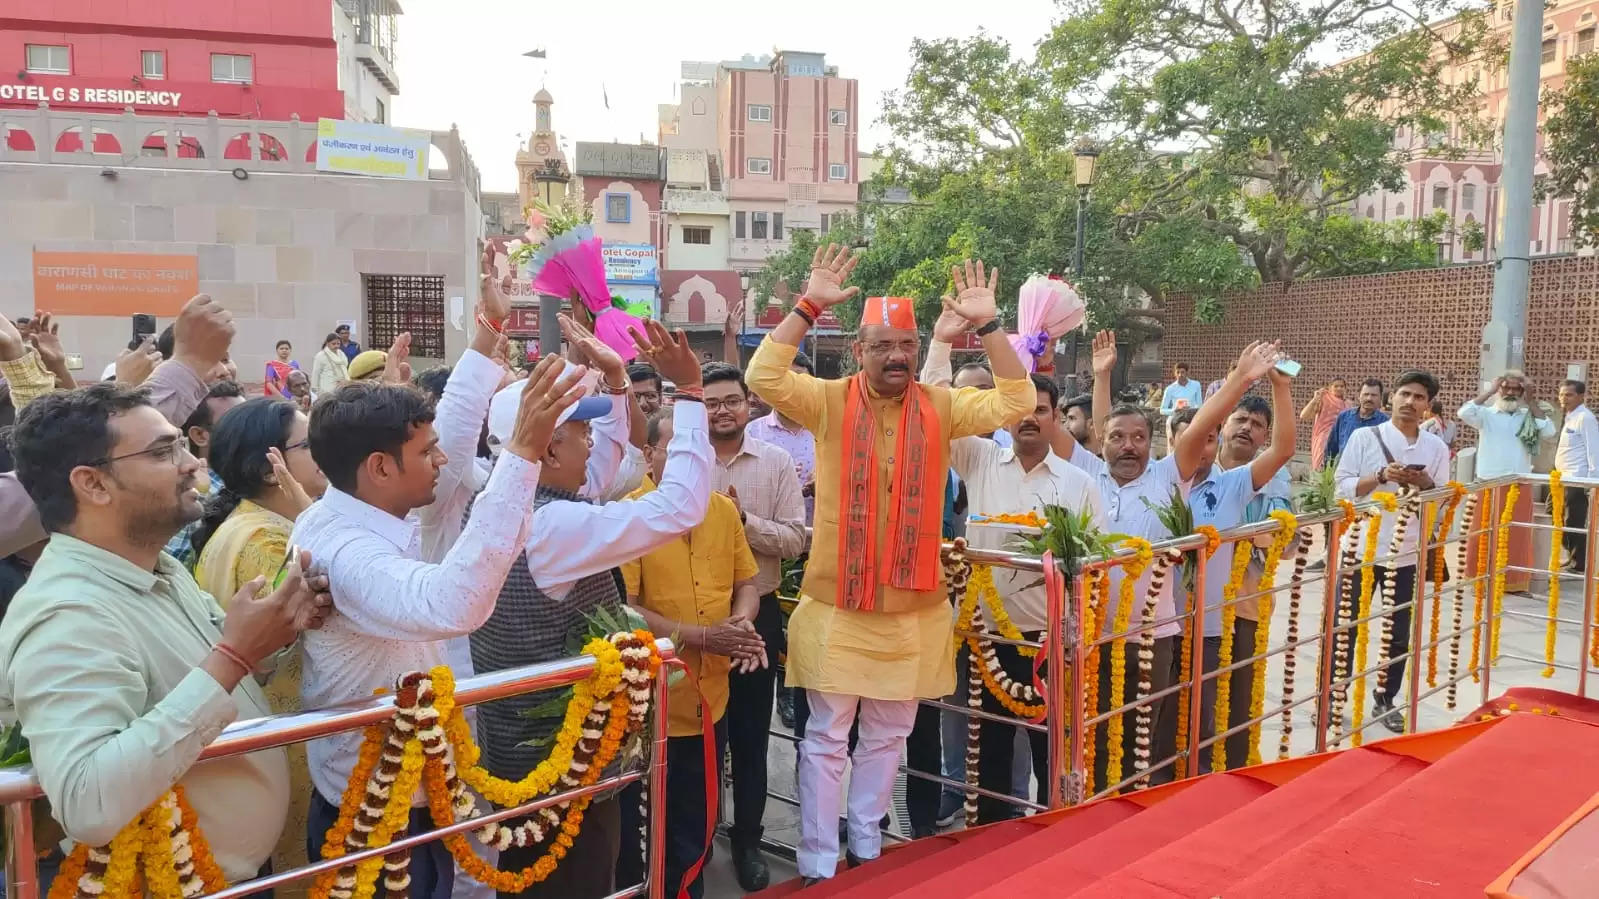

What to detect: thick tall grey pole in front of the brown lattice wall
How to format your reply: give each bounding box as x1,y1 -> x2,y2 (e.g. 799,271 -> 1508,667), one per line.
1479,0 -> 1543,381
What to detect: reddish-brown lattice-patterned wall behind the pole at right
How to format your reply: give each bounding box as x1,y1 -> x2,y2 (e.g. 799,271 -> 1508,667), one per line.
1161,256 -> 1599,450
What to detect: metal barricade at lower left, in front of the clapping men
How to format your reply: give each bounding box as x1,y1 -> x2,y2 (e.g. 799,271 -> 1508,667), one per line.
0,638 -> 683,899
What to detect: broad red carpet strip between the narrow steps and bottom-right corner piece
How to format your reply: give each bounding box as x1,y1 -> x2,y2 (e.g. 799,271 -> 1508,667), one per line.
1226,713 -> 1599,899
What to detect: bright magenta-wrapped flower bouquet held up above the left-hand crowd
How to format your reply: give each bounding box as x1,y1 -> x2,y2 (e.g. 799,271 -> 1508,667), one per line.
508,198 -> 644,362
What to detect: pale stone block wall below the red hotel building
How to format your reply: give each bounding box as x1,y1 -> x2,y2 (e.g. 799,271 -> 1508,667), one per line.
0,160 -> 483,382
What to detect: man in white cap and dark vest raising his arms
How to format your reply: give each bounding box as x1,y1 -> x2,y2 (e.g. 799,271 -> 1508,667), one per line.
472,322 -> 712,899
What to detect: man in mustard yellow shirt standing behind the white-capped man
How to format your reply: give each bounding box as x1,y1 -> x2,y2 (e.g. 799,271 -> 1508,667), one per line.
617,410 -> 766,899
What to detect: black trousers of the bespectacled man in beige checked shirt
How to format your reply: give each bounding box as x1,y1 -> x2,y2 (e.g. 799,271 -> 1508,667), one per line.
723,593 -> 784,851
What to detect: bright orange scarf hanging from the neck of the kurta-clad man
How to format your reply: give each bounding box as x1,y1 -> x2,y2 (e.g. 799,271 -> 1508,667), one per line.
838,373 -> 945,611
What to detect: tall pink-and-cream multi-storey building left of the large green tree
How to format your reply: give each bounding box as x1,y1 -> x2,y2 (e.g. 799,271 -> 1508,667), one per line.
660,50 -> 860,334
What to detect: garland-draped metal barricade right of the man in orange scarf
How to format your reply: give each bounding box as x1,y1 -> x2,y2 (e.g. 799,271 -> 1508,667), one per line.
748,475 -> 1599,856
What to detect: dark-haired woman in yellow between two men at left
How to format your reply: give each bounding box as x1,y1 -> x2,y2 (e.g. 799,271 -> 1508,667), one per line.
193,397 -> 328,896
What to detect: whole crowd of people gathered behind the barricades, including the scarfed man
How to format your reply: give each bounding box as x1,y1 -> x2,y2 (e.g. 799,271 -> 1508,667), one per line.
0,239 -> 1599,899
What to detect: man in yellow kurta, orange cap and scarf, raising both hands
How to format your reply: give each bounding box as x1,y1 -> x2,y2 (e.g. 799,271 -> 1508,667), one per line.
745,246 -> 1036,883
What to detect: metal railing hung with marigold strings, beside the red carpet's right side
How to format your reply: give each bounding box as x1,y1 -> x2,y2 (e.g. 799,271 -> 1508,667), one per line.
751,475 -> 1599,854
